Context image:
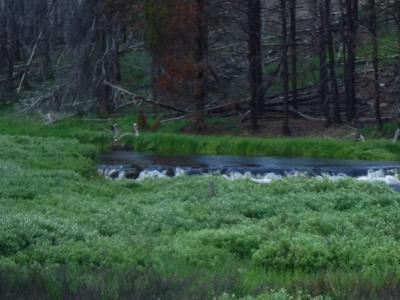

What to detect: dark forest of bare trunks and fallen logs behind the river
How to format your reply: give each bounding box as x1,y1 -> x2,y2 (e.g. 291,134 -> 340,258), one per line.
0,0 -> 400,135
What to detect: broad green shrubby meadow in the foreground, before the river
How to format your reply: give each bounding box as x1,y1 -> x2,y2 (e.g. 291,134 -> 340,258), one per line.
0,136 -> 400,300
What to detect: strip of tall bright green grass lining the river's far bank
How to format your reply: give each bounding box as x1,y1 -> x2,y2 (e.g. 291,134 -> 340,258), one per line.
126,133 -> 400,161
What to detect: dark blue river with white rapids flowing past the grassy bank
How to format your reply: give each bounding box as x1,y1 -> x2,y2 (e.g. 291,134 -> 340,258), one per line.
98,151 -> 400,191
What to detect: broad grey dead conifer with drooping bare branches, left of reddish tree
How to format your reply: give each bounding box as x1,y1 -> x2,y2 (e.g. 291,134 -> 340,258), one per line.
62,0 -> 119,113
